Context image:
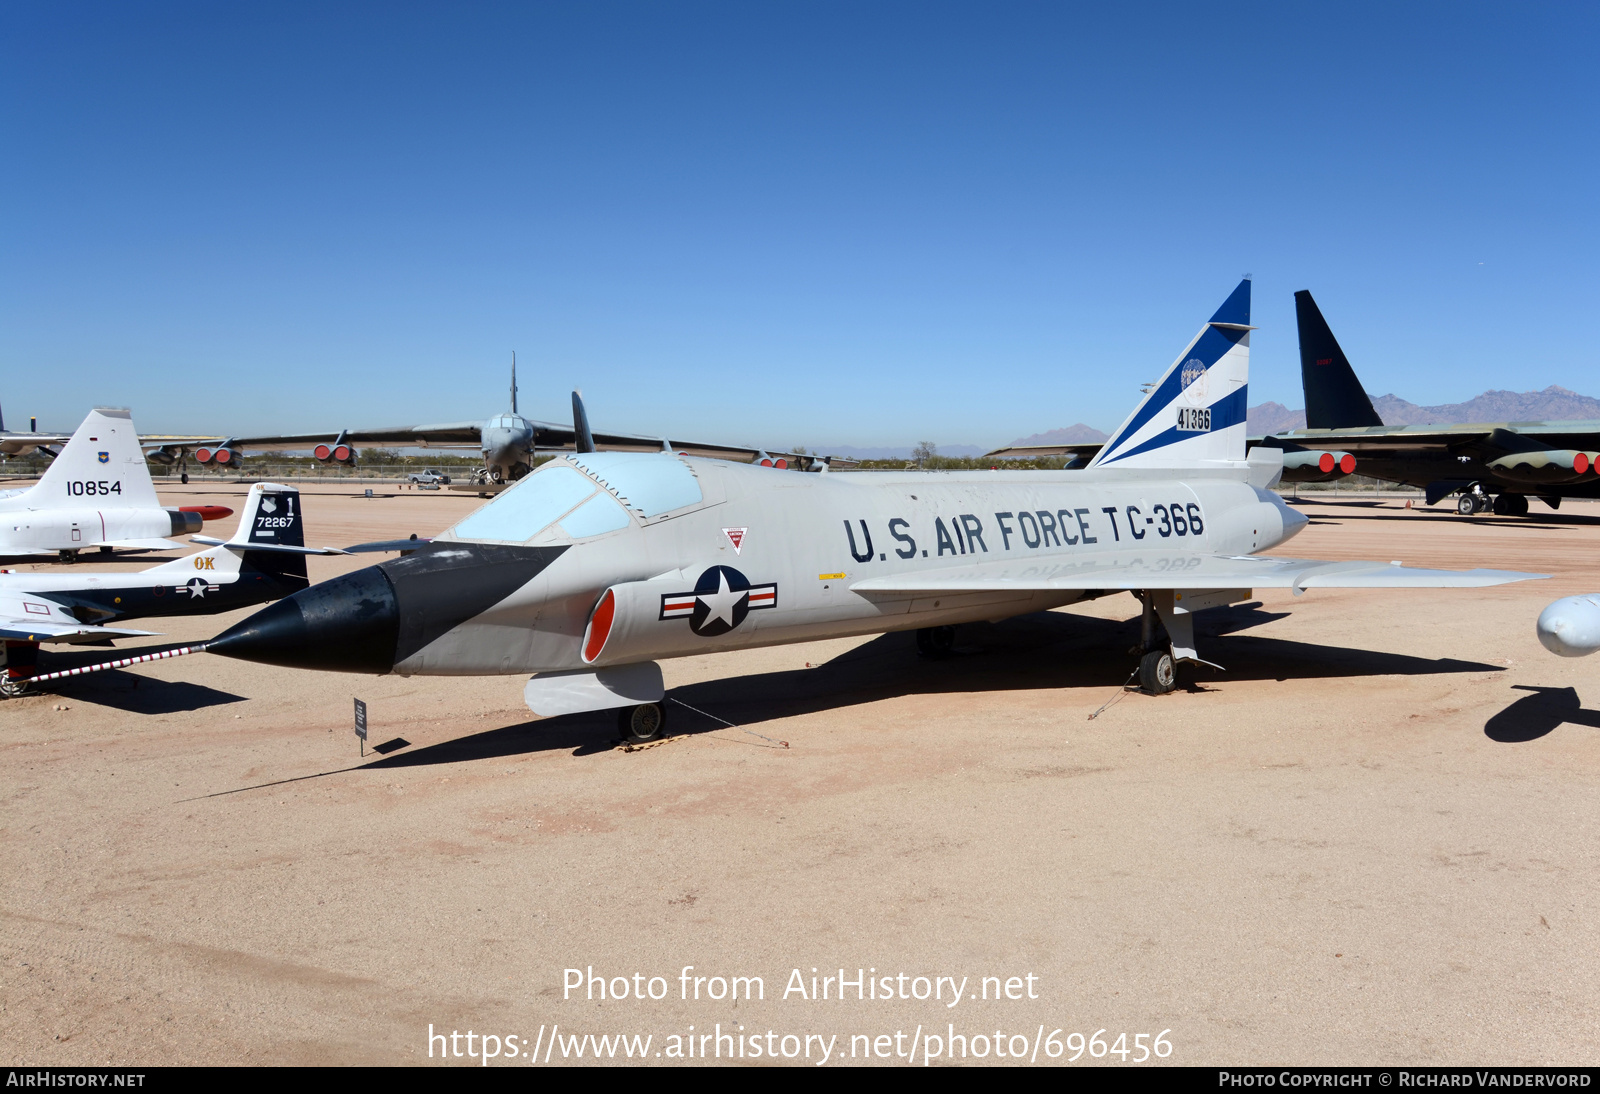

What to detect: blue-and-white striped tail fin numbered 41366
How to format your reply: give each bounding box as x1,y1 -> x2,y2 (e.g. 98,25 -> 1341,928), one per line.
1090,278 -> 1254,467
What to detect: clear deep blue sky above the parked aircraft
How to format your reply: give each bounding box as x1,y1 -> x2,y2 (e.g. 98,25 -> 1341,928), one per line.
0,0 -> 1600,446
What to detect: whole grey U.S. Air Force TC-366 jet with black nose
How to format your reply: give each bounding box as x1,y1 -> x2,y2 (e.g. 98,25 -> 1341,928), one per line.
43,280 -> 1534,741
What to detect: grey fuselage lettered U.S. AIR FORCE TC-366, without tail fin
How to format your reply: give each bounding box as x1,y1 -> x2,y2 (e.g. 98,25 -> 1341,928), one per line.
213,454 -> 1304,675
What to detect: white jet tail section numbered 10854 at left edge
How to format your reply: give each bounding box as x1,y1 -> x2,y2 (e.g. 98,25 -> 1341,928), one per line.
0,406 -> 234,561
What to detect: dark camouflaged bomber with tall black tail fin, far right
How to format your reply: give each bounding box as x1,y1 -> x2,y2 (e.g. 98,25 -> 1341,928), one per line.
1259,289 -> 1600,517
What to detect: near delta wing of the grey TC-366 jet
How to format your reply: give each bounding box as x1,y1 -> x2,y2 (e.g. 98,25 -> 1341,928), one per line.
850,553 -> 1549,597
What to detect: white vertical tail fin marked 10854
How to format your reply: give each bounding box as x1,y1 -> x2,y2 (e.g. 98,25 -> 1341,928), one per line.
27,406 -> 162,509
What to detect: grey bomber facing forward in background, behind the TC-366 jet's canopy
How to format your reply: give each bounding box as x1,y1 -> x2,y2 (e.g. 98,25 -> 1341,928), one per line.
180,361 -> 816,483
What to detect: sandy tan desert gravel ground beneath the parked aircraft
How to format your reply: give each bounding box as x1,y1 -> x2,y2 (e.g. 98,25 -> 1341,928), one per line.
0,483 -> 1600,1065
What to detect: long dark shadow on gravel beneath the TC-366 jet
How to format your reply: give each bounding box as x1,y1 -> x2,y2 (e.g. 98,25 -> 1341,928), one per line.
366,605 -> 1504,768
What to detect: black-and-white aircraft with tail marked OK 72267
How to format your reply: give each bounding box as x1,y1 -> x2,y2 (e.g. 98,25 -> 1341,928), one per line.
0,483 -> 342,697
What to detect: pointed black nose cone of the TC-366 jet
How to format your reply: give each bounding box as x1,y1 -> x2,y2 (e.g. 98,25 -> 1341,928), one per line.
206,566 -> 400,673
